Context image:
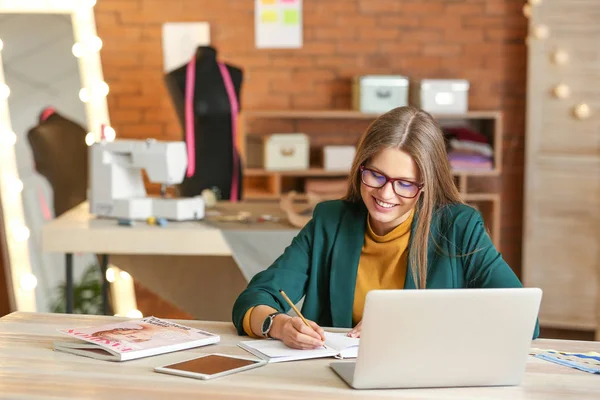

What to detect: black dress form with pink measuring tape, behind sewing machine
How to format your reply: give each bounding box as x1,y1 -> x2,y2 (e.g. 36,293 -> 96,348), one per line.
165,46 -> 243,200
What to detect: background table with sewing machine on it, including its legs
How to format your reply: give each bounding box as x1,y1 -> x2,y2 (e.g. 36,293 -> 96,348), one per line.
42,202 -> 298,321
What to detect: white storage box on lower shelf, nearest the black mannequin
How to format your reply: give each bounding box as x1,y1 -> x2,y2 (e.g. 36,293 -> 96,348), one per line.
246,133 -> 310,171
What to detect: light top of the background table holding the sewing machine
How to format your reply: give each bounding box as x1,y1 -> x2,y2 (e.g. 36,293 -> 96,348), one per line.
42,202 -> 297,256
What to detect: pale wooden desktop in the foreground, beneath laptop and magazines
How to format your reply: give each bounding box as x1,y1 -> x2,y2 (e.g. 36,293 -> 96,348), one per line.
0,313 -> 600,400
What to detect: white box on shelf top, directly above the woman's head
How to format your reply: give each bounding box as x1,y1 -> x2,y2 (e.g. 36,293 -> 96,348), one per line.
352,75 -> 409,113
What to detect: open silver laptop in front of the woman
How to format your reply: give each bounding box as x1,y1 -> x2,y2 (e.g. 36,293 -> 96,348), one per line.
330,288 -> 542,389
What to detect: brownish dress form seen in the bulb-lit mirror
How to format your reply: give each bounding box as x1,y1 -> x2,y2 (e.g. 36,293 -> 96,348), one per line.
27,111 -> 88,217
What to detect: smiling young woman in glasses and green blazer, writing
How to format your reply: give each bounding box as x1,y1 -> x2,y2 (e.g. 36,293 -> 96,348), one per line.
233,107 -> 539,349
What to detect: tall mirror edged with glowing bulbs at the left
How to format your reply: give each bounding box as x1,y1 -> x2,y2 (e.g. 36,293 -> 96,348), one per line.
0,0 -> 114,312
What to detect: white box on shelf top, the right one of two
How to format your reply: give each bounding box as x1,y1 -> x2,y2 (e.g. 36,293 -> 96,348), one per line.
416,79 -> 469,114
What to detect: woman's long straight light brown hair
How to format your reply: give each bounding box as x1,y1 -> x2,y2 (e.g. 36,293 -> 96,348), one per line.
344,106 -> 463,289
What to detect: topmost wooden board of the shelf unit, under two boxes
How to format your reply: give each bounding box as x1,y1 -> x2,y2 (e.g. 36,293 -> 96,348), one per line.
243,110 -> 501,120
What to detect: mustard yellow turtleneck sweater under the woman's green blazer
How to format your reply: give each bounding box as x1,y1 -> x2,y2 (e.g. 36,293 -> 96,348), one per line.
243,211 -> 414,337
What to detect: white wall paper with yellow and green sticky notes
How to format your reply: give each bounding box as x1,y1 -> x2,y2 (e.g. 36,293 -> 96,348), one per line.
254,0 -> 302,49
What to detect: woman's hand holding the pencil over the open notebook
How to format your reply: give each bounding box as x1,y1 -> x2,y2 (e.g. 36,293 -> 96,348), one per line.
270,314 -> 325,350
